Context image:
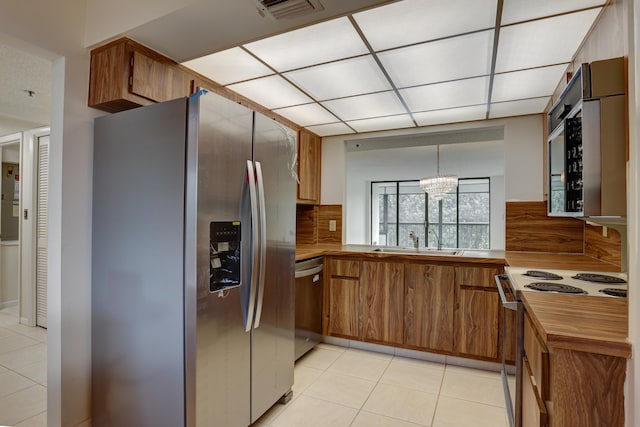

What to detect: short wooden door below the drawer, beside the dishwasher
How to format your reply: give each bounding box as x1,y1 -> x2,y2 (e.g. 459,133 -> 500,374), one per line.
328,278 -> 361,339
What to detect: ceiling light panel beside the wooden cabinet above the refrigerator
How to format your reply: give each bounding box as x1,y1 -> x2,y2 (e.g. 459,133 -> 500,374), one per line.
182,47 -> 273,85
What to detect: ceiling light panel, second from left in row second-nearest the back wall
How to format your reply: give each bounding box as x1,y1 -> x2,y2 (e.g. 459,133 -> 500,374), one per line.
321,92 -> 406,121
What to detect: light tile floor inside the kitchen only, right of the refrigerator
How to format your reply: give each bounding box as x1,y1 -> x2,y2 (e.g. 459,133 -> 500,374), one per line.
254,344 -> 509,427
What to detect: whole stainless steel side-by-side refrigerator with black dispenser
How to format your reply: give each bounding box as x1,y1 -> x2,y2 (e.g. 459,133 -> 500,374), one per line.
91,93 -> 296,427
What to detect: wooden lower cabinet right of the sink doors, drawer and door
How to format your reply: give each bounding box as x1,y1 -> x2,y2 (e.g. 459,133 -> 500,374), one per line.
454,267 -> 501,361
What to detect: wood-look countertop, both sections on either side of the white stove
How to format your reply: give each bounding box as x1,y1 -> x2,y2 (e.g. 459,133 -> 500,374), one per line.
296,244 -> 631,358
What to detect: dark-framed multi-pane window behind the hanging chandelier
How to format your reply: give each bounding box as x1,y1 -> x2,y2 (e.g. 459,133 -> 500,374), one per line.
371,178 -> 490,249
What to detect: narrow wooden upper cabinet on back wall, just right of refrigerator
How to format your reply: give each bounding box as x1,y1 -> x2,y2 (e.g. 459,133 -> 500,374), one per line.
298,129 -> 322,204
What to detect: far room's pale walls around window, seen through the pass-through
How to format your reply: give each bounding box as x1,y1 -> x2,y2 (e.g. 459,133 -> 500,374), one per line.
344,141 -> 504,249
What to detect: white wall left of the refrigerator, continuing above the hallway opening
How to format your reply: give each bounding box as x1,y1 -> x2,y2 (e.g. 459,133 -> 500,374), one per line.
0,0 -> 97,427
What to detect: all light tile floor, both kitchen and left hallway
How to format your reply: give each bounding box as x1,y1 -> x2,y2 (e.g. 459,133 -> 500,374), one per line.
0,309 -> 508,427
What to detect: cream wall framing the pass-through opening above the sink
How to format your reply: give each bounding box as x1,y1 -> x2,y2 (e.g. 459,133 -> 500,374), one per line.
321,115 -> 544,247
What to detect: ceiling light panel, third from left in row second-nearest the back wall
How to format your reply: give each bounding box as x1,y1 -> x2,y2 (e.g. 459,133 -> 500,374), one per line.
400,77 -> 489,112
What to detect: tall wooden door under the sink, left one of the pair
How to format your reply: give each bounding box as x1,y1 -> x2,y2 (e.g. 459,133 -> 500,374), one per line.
360,261 -> 404,344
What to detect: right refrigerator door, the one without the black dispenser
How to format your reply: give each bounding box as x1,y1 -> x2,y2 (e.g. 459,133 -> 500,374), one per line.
251,113 -> 296,422
